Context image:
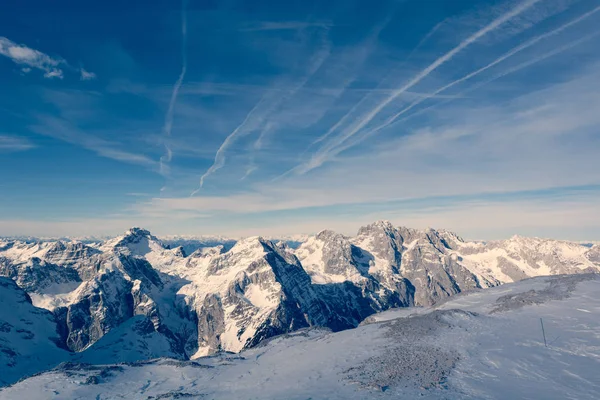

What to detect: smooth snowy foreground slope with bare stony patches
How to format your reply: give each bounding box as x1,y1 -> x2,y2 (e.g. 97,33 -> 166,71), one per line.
0,274 -> 600,399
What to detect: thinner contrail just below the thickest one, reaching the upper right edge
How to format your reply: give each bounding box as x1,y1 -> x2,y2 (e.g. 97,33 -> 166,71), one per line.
336,6 -> 600,154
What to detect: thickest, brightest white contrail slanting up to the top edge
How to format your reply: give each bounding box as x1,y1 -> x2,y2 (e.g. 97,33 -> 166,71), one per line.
300,0 -> 541,172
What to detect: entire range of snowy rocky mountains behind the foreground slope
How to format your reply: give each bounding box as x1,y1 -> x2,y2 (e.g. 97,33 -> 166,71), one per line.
0,221 -> 600,388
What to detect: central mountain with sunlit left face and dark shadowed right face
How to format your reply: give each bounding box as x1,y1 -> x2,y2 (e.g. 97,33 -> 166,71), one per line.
179,234 -> 390,356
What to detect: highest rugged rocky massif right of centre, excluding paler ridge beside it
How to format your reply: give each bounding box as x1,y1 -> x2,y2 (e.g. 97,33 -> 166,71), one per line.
296,221 -> 487,311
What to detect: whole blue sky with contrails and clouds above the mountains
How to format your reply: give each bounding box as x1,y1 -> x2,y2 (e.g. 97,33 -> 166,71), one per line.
0,0 -> 600,240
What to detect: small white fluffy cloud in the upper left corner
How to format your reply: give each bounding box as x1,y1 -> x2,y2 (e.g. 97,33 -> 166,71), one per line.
0,36 -> 96,80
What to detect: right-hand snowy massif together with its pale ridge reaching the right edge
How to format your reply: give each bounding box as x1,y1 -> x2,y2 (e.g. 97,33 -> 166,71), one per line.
296,221 -> 600,306
